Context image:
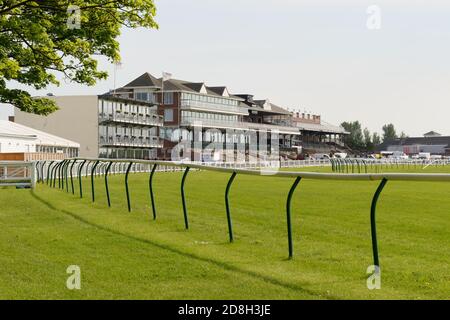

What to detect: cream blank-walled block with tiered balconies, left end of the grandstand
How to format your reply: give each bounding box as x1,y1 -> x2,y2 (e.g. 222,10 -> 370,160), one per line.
14,95 -> 163,159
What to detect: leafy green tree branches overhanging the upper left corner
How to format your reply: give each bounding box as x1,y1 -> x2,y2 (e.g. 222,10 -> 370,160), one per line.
0,0 -> 158,115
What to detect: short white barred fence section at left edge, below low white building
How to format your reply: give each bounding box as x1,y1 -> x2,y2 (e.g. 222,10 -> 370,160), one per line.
0,161 -> 36,188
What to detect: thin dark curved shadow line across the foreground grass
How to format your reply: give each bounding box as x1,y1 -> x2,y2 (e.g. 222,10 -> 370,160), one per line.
31,190 -> 338,300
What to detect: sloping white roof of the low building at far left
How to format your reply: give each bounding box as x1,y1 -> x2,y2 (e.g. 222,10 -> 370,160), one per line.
0,120 -> 80,148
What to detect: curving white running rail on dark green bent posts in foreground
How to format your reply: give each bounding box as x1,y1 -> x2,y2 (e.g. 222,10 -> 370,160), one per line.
37,158 -> 450,276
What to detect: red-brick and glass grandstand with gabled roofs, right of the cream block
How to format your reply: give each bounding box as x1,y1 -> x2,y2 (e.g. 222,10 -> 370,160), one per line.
109,73 -> 346,161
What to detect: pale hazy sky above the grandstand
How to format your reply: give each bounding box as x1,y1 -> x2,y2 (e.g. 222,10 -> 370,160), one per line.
0,0 -> 450,136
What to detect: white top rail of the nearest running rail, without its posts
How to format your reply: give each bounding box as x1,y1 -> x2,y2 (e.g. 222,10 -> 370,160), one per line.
68,158 -> 450,181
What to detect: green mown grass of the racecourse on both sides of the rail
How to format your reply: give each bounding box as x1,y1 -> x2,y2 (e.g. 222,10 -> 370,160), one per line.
0,167 -> 450,299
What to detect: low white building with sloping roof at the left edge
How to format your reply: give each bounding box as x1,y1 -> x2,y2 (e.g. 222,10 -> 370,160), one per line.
0,120 -> 80,160
